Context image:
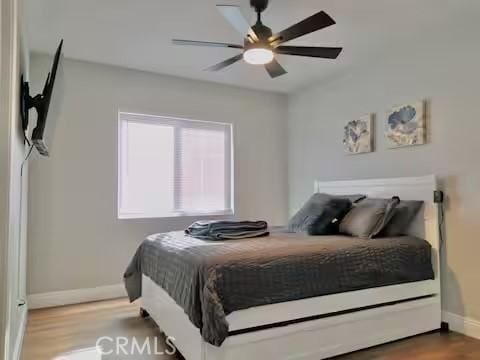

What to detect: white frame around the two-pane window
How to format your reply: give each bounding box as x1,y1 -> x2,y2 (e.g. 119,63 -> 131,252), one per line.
117,110 -> 235,220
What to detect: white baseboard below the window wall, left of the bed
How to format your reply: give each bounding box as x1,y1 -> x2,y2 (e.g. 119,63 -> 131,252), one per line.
28,284 -> 127,309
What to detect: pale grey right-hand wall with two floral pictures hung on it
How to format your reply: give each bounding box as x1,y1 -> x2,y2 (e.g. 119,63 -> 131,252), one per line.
288,11 -> 480,320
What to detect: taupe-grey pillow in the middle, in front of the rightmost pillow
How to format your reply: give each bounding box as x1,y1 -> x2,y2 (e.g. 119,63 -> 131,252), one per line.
340,197 -> 400,239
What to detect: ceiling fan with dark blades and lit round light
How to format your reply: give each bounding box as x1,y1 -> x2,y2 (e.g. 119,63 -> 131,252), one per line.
172,0 -> 342,78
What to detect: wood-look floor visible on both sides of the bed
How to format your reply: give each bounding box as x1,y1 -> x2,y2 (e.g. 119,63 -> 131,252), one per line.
22,299 -> 480,360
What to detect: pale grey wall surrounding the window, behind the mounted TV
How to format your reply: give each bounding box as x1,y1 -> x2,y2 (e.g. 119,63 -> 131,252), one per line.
28,54 -> 287,294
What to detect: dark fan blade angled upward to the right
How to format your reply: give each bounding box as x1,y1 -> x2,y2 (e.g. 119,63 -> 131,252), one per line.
269,11 -> 335,46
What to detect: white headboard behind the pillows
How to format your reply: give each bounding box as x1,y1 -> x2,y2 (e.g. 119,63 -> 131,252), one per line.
314,175 -> 440,281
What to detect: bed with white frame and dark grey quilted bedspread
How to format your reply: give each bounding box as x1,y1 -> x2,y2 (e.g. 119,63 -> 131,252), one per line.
129,176 -> 441,360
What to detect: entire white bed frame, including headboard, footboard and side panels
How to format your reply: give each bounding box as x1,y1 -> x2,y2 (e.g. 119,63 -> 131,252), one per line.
142,175 -> 441,360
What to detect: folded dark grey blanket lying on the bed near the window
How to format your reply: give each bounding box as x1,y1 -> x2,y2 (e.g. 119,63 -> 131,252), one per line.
185,220 -> 269,240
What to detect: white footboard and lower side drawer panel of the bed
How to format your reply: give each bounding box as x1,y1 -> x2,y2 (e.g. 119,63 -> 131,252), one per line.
142,276 -> 441,360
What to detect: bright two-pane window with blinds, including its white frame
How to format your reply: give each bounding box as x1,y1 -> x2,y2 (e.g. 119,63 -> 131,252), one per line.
118,112 -> 233,219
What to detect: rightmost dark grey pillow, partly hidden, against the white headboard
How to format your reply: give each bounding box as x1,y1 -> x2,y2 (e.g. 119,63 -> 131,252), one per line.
378,200 -> 423,237
